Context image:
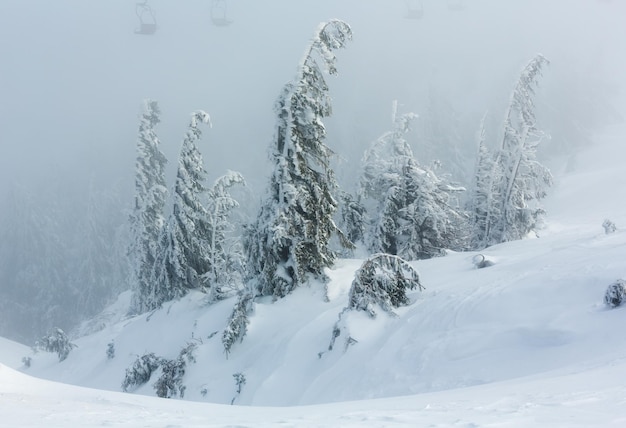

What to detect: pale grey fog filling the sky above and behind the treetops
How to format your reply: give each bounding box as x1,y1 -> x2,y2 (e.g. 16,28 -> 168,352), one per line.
0,0 -> 626,200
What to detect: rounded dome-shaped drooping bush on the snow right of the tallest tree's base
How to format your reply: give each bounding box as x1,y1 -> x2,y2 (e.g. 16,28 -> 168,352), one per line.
348,253 -> 424,318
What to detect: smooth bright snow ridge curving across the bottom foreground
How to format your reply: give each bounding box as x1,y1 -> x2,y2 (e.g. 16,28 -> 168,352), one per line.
0,359 -> 626,428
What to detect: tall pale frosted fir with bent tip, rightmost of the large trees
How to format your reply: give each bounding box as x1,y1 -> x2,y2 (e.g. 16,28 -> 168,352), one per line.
474,55 -> 552,246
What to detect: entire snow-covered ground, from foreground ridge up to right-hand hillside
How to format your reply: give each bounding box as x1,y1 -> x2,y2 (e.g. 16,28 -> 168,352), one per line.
0,129 -> 626,428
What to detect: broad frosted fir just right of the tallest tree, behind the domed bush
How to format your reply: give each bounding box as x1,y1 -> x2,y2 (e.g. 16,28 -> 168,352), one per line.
359,113 -> 464,260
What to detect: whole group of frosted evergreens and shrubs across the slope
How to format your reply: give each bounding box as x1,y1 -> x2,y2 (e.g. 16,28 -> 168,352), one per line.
1,20 -> 560,401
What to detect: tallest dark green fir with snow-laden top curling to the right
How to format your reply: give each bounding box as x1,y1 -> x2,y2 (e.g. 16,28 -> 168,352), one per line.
246,20 -> 352,298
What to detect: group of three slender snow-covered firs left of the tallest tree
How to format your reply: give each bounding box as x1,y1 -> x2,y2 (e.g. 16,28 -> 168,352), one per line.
129,107 -> 244,313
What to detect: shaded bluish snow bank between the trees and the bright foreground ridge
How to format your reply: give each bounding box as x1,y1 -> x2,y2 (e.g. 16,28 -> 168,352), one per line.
13,225 -> 626,406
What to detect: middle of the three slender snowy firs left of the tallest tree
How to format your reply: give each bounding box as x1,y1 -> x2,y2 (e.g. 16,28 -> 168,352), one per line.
151,111 -> 213,309
